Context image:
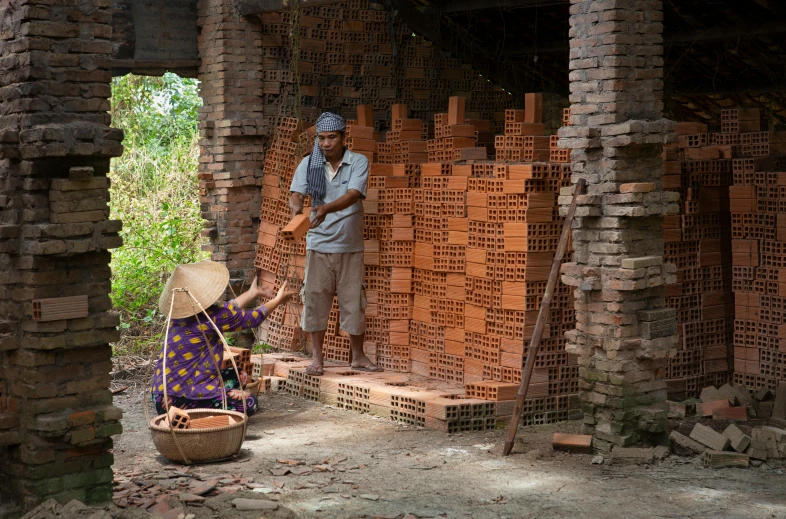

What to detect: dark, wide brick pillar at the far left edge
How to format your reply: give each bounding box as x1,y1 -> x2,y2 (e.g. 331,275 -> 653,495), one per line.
0,0 -> 123,515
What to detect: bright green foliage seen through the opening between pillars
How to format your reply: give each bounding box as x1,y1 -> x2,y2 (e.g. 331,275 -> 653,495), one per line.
110,74 -> 208,352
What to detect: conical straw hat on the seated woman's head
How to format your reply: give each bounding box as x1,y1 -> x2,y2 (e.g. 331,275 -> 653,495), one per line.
158,261 -> 229,319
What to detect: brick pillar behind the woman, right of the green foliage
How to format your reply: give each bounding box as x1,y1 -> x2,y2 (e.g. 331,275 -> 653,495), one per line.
197,0 -> 266,291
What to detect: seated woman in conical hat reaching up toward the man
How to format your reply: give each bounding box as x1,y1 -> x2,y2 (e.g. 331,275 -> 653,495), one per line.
151,261 -> 295,416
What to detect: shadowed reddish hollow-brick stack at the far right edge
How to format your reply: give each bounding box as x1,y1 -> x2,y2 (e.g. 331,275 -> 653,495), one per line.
714,109 -> 786,390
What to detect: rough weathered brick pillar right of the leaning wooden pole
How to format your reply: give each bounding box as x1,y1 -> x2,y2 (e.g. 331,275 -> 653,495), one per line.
559,0 -> 678,450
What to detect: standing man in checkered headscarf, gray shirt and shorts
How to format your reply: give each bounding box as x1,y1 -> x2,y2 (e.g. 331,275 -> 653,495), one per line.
289,112 -> 382,376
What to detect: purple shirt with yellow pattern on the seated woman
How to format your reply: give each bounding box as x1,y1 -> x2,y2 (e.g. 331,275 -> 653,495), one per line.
152,299 -> 268,400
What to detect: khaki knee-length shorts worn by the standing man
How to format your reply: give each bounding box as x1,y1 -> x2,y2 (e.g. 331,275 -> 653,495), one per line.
300,250 -> 366,335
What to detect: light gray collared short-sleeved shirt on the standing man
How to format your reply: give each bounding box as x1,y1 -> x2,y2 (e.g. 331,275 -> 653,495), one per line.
289,150 -> 368,253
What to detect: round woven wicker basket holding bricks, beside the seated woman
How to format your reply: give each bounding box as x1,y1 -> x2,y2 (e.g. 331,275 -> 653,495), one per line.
150,409 -> 248,463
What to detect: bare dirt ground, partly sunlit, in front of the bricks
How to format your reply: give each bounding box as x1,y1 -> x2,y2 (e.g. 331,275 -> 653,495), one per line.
115,391 -> 786,519
